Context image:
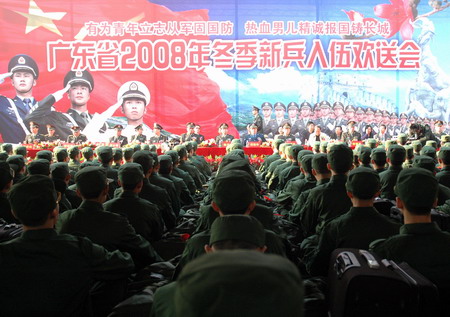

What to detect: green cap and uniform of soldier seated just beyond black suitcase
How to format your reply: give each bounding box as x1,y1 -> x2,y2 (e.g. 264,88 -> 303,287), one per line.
304,167 -> 400,276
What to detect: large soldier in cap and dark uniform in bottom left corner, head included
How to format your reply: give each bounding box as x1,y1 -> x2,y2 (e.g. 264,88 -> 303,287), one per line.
0,175 -> 134,316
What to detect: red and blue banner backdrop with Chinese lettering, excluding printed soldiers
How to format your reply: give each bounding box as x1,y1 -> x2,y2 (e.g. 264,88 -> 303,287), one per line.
0,0 -> 450,138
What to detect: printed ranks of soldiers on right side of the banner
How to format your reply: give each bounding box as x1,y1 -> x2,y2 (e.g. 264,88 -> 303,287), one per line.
250,101 -> 450,146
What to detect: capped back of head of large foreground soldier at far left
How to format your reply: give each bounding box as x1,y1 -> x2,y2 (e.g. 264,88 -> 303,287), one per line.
8,175 -> 57,227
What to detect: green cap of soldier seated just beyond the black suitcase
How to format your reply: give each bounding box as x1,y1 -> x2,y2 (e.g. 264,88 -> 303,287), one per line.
345,166 -> 380,199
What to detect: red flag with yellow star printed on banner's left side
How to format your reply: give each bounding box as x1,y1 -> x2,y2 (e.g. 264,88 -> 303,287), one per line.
0,0 -> 237,138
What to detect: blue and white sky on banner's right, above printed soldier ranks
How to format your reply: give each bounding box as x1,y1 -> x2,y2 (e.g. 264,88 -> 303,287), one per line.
152,0 -> 450,126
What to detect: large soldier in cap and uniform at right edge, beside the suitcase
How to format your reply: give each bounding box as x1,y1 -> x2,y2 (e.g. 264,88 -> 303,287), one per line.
370,168 -> 450,288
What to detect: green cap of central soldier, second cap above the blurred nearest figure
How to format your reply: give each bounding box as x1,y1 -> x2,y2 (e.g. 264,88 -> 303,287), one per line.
212,169 -> 255,214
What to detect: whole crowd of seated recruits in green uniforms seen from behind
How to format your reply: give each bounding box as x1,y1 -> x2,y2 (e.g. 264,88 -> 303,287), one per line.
0,136 -> 450,316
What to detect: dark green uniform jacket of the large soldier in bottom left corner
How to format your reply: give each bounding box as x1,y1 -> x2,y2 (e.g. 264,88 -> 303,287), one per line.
0,229 -> 134,316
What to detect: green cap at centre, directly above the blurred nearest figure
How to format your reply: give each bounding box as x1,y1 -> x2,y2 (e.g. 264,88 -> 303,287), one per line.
209,215 -> 266,248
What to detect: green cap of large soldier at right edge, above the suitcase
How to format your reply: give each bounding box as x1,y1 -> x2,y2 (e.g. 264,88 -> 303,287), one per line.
394,167 -> 439,208
